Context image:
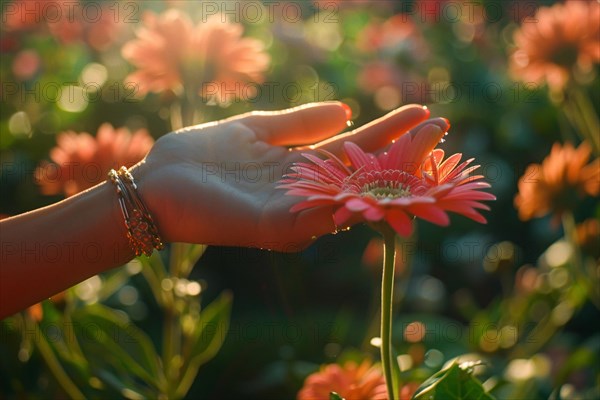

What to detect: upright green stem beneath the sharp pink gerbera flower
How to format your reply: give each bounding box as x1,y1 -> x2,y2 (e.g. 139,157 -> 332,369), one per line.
381,228 -> 396,400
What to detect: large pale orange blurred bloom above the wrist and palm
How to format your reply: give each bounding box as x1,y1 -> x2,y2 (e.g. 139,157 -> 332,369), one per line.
122,9 -> 270,103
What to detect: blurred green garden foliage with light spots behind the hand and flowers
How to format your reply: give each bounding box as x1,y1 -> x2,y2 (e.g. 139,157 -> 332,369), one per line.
0,0 -> 600,399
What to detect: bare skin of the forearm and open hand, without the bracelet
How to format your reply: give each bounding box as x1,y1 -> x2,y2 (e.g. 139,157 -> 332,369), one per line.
0,102 -> 432,319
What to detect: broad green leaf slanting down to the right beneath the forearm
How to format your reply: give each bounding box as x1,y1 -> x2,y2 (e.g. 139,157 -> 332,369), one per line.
72,304 -> 166,389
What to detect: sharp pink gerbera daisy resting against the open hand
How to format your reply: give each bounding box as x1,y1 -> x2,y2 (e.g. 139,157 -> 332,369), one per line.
280,124 -> 495,236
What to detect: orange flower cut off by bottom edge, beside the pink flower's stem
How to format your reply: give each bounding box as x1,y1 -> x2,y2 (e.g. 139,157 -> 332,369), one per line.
298,360 -> 387,400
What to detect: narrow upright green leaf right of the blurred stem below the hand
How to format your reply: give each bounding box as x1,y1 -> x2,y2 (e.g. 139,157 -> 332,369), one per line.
176,292 -> 232,397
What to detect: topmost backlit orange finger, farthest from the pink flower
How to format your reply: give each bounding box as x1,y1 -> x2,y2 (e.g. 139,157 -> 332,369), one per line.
240,101 -> 351,146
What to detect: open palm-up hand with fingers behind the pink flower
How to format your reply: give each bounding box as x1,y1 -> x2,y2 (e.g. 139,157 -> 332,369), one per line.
132,102 -> 436,251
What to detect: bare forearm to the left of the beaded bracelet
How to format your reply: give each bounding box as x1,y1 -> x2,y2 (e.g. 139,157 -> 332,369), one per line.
0,182 -> 134,319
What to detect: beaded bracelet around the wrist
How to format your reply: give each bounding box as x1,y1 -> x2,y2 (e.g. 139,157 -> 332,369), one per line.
108,167 -> 164,256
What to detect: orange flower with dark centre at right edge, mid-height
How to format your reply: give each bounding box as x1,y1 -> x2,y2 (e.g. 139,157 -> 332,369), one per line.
515,142 -> 600,221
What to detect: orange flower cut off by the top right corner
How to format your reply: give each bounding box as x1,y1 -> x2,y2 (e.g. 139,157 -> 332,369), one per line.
510,1 -> 600,90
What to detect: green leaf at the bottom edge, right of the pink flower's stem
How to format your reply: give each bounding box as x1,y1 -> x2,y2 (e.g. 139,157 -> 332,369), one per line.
412,363 -> 494,400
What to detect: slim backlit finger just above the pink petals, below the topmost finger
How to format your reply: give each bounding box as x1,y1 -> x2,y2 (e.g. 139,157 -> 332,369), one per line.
314,104 -> 429,161
